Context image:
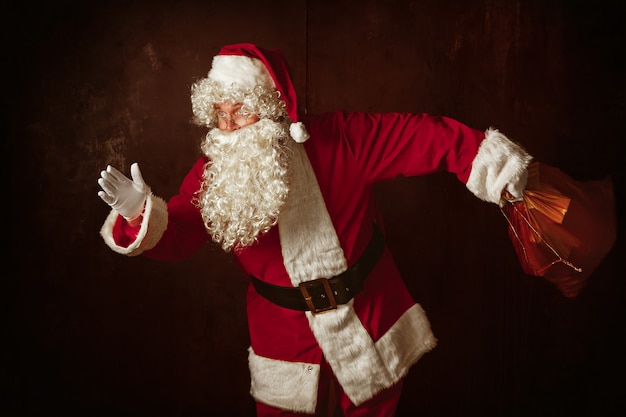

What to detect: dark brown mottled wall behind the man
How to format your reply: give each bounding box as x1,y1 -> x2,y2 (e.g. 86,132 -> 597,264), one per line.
0,0 -> 626,416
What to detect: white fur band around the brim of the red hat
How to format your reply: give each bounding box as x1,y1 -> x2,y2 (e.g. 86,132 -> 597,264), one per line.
208,55 -> 276,90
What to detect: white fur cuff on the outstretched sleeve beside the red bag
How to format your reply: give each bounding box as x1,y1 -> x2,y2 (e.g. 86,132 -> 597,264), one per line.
466,129 -> 532,204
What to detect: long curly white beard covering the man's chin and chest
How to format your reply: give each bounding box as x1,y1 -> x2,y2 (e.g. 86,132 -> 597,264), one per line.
197,119 -> 291,252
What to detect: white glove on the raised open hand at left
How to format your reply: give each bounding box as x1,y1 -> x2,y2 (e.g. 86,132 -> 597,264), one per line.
98,162 -> 148,223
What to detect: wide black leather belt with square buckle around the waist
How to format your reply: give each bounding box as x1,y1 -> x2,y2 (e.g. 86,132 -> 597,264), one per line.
250,224 -> 385,314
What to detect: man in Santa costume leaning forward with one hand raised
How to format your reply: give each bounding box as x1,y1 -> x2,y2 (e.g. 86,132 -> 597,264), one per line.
98,44 -> 531,416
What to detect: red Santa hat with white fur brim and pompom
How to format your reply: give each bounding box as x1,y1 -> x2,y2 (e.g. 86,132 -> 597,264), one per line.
208,43 -> 309,143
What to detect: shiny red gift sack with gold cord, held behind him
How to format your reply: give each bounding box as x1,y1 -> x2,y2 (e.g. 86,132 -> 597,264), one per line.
500,162 -> 617,298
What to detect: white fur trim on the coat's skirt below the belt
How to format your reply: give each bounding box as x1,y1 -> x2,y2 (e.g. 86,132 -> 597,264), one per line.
249,303 -> 437,414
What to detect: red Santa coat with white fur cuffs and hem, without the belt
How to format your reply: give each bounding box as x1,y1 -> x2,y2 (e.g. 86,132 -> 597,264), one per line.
101,112 -> 530,413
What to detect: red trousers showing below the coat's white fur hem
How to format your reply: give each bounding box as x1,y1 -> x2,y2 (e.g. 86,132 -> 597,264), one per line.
256,354 -> 403,417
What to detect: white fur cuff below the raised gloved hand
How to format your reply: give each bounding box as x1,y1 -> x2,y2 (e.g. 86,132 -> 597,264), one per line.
100,194 -> 168,256
